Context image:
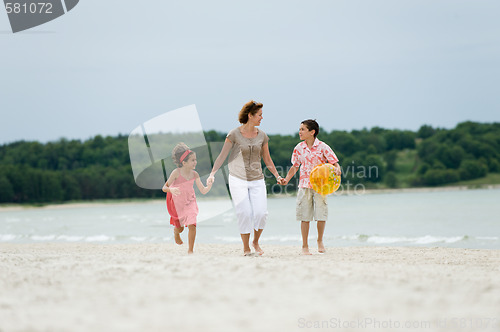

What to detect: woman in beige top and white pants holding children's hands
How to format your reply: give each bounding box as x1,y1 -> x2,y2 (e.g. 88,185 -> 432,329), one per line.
207,100 -> 282,256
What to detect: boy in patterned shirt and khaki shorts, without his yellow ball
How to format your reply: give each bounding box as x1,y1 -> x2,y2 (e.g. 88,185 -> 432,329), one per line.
280,120 -> 341,255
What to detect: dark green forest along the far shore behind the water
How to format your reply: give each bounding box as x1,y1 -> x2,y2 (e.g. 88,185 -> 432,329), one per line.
0,122 -> 500,204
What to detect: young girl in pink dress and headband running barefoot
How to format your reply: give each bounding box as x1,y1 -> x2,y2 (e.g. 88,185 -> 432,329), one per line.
162,143 -> 212,254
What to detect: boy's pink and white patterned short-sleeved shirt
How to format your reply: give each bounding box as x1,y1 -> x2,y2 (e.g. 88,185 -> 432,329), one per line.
292,138 -> 339,188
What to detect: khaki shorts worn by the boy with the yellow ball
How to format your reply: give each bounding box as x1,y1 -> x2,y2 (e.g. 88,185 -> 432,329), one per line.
296,188 -> 328,221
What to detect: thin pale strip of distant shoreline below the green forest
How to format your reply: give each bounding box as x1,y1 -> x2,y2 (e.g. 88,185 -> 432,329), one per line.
0,184 -> 500,212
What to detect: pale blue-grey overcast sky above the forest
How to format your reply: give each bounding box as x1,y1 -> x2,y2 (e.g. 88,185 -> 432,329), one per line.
0,0 -> 500,144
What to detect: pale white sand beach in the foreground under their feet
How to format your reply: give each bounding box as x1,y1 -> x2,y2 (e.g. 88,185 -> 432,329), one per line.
0,244 -> 500,332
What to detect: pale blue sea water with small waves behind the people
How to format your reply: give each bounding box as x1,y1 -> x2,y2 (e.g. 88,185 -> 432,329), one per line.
0,189 -> 500,249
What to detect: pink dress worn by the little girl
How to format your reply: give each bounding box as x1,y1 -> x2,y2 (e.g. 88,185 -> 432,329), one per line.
167,174 -> 198,227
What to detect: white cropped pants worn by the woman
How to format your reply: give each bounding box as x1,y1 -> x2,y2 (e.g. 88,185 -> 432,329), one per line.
229,175 -> 267,234
